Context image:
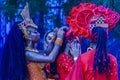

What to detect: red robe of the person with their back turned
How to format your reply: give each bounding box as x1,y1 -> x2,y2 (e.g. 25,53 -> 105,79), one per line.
66,50 -> 118,80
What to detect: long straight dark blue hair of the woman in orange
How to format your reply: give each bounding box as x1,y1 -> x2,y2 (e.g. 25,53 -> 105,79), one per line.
0,22 -> 28,80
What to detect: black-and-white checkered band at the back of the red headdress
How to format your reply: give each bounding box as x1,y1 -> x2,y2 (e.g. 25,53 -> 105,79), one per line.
90,16 -> 108,30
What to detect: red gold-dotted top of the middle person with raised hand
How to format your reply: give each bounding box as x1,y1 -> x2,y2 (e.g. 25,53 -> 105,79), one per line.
57,53 -> 74,80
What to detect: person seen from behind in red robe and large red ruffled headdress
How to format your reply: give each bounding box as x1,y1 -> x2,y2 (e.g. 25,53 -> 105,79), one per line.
66,3 -> 119,80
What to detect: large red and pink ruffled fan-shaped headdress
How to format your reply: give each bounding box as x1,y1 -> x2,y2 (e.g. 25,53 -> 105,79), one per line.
66,3 -> 120,37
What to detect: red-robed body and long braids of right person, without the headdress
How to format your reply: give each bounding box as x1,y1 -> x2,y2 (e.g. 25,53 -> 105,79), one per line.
66,26 -> 118,80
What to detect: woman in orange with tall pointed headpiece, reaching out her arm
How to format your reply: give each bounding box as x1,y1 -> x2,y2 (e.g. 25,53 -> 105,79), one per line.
0,2 -> 65,80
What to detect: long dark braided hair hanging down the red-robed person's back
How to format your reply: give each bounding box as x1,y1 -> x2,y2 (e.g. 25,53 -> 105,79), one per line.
92,27 -> 110,74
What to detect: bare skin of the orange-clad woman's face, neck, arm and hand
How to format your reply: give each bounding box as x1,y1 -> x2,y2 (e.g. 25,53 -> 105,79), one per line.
25,27 -> 65,62
